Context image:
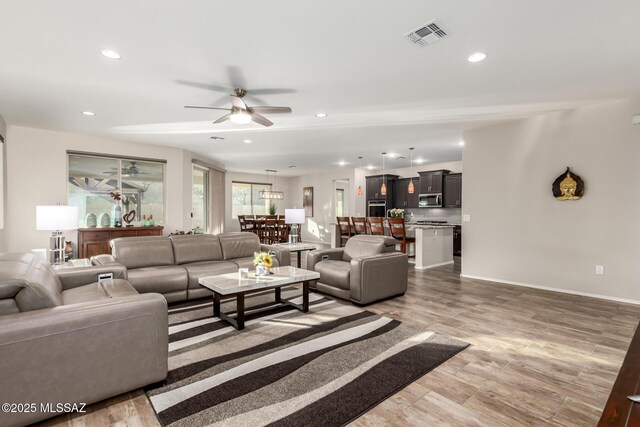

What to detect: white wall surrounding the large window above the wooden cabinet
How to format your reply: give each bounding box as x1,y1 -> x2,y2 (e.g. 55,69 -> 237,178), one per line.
5,125 -> 191,251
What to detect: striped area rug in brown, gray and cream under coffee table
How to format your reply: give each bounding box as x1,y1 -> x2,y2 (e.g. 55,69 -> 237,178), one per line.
147,287 -> 468,427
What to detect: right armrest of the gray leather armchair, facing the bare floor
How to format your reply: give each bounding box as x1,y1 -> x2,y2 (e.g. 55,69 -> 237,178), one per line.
349,252 -> 409,304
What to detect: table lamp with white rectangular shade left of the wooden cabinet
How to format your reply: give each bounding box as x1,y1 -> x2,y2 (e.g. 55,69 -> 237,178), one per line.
36,205 -> 78,265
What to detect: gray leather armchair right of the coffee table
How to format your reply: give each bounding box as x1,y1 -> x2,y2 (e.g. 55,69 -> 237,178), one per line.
307,235 -> 408,304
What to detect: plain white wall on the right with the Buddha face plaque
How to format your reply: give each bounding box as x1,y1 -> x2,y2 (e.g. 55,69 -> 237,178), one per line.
462,99 -> 640,302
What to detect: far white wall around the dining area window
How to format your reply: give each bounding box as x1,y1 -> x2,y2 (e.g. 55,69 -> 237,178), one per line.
224,171 -> 294,232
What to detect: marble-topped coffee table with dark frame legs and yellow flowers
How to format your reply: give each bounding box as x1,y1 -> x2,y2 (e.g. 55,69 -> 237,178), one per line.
198,266 -> 320,330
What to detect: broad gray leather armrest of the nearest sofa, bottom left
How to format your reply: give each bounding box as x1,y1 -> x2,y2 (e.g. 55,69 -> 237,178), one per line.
0,294 -> 168,426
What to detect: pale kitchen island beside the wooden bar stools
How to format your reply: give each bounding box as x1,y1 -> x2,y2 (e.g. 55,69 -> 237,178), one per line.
406,223 -> 455,270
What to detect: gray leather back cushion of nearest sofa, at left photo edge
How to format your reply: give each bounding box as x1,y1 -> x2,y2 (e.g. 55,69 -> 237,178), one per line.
0,253 -> 62,314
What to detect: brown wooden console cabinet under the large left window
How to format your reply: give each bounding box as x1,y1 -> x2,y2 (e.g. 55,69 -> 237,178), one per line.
78,226 -> 164,258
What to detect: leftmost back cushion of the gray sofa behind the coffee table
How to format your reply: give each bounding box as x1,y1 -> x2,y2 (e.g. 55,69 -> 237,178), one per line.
110,236 -> 174,269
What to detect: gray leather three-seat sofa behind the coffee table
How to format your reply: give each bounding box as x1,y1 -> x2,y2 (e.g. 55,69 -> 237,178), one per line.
91,232 -> 291,302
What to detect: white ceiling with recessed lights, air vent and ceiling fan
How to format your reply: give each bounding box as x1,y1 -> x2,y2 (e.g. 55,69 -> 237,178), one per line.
0,0 -> 640,175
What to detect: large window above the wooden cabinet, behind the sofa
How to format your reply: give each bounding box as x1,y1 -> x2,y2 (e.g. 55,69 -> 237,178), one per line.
67,153 -> 165,227
